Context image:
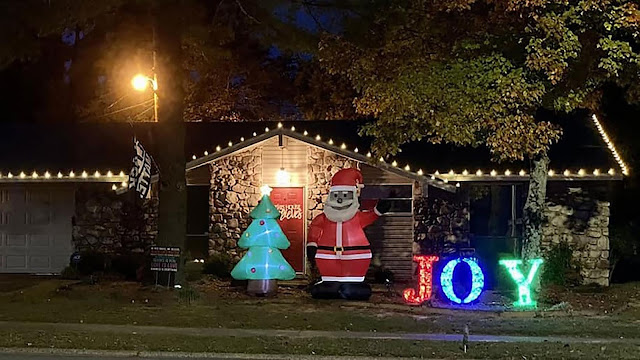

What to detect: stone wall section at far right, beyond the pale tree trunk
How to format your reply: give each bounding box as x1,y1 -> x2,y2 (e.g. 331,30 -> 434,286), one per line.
542,188 -> 610,286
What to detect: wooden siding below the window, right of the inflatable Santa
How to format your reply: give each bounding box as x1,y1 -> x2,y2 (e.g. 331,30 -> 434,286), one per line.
365,215 -> 413,281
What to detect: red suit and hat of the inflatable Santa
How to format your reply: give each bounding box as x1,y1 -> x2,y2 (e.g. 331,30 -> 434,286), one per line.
308,168 -> 380,282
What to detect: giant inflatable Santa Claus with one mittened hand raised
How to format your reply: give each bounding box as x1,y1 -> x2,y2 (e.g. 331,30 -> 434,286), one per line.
307,168 -> 389,300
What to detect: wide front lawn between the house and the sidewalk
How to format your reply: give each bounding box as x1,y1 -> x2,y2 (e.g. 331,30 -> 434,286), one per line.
0,279 -> 640,338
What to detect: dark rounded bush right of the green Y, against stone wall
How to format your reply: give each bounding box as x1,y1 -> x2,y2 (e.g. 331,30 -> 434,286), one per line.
541,242 -> 581,286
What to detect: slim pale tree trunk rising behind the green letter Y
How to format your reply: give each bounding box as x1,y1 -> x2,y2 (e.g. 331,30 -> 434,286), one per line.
522,153 -> 549,262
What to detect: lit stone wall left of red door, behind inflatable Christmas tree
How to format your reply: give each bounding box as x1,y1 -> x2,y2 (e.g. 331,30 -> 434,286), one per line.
209,147 -> 262,262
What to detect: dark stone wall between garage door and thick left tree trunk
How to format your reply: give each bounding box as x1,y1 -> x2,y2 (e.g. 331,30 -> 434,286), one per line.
72,184 -> 158,254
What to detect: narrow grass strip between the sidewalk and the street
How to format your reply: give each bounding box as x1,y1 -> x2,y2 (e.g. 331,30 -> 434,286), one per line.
0,330 -> 640,359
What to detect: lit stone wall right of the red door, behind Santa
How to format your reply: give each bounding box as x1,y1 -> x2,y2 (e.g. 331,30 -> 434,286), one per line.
307,146 -> 358,223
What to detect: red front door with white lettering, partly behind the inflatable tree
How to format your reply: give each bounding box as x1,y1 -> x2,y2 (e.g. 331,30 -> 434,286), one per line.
271,187 -> 304,272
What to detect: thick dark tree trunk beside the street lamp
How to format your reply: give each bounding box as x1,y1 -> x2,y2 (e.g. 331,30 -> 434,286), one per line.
153,0 -> 187,283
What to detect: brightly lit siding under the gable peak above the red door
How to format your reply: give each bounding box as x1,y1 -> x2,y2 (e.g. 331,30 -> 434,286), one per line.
262,136 -> 308,187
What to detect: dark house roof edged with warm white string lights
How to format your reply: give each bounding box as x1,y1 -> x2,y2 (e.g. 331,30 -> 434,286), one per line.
0,117 -> 626,184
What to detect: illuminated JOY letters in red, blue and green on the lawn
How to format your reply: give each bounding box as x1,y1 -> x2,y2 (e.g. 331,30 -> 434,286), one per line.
403,255 -> 542,307
